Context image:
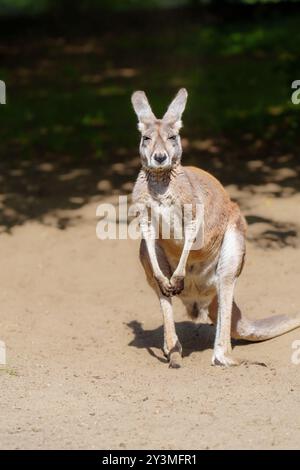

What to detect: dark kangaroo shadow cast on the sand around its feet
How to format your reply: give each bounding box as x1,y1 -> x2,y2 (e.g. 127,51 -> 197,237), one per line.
127,320 -> 215,363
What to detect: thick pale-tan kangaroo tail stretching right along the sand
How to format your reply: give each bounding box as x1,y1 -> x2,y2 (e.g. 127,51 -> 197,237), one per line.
231,305 -> 300,341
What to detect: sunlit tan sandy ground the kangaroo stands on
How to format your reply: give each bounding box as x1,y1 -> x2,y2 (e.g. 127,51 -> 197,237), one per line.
0,187 -> 300,449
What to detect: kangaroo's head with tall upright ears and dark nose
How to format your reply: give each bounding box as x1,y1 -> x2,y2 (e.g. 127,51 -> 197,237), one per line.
131,88 -> 187,171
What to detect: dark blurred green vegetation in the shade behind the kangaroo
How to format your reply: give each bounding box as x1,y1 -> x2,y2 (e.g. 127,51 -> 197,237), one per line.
0,0 -> 300,230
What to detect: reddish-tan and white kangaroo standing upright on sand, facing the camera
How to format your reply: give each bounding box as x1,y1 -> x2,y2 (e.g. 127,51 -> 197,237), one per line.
132,88 -> 300,368
